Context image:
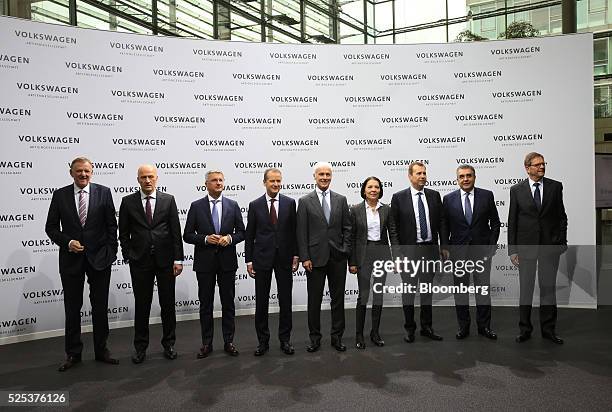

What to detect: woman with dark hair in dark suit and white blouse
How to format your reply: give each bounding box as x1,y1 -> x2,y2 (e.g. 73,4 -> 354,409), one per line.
349,176 -> 391,349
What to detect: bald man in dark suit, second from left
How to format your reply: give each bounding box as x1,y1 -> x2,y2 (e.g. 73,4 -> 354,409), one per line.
119,165 -> 183,364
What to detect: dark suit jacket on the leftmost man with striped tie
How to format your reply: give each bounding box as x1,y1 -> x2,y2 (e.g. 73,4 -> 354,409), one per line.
45,183 -> 117,273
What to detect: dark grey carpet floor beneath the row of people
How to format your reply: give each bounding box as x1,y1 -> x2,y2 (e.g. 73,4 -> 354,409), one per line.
0,307 -> 612,411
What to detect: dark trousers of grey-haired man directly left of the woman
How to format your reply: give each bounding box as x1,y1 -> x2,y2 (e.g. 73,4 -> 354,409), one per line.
306,251 -> 347,343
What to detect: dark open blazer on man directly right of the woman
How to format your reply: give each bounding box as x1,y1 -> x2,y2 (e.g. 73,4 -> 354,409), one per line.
389,188 -> 446,256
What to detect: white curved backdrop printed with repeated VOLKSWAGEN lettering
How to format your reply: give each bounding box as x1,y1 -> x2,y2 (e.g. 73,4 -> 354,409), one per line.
0,18 -> 596,343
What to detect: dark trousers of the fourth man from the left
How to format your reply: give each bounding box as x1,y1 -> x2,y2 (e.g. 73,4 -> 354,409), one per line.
254,253 -> 293,346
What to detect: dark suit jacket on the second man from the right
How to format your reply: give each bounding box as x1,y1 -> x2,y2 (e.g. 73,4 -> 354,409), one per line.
440,187 -> 501,256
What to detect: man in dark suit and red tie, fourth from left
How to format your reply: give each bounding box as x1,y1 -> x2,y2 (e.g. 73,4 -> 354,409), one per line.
244,169 -> 299,356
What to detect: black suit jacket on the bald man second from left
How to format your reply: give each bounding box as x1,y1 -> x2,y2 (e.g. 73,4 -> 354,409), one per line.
119,190 -> 183,267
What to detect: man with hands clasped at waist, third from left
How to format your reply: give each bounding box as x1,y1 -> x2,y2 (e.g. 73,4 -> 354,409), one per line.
183,170 -> 244,359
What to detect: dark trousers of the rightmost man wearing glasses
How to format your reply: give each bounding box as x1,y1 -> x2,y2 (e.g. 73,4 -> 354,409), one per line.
519,253 -> 559,334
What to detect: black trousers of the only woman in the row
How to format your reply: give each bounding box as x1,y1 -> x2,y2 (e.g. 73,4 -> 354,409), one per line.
355,241 -> 391,335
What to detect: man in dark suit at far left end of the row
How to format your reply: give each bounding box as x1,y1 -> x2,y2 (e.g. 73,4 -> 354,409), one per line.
45,157 -> 119,372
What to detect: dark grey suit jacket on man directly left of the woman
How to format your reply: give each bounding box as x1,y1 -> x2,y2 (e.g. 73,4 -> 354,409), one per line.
297,190 -> 351,267
